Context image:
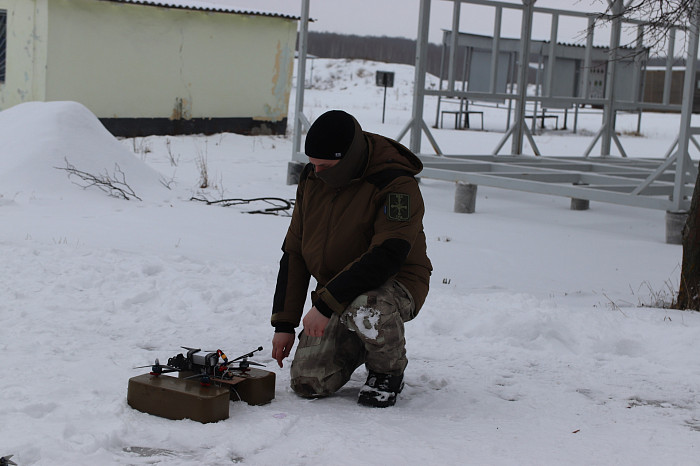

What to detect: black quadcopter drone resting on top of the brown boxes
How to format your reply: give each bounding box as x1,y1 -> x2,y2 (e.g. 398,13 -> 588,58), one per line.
134,346 -> 264,385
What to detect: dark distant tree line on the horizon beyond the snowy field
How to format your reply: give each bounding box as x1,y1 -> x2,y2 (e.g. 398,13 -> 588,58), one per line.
307,32 -> 442,76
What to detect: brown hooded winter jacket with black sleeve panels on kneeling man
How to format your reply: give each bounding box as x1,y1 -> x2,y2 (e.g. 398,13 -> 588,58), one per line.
272,132 -> 432,333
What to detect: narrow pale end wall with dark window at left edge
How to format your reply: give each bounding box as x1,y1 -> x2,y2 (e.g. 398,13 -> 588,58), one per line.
0,0 -> 48,110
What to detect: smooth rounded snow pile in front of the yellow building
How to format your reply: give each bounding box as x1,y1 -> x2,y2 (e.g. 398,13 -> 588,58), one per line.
0,102 -> 166,200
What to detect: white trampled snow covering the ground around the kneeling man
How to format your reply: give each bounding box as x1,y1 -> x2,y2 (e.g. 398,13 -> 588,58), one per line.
0,60 -> 700,465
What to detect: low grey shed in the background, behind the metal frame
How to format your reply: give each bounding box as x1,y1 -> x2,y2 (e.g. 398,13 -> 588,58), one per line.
434,28 -> 652,134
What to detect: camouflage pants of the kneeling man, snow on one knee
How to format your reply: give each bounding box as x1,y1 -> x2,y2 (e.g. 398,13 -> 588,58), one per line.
290,279 -> 416,397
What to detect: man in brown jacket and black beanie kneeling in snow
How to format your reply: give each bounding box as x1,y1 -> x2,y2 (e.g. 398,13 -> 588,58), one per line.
271,110 -> 432,407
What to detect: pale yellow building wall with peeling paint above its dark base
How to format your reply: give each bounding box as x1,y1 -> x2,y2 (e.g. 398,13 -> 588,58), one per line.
0,0 -> 297,135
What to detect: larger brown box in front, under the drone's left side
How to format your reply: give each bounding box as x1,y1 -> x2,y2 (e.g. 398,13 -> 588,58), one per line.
127,374 -> 230,423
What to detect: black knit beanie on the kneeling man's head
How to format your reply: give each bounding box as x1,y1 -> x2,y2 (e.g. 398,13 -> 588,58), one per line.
304,110 -> 362,160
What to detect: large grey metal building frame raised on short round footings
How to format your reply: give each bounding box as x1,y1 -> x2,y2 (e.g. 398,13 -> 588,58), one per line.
292,0 -> 700,226
